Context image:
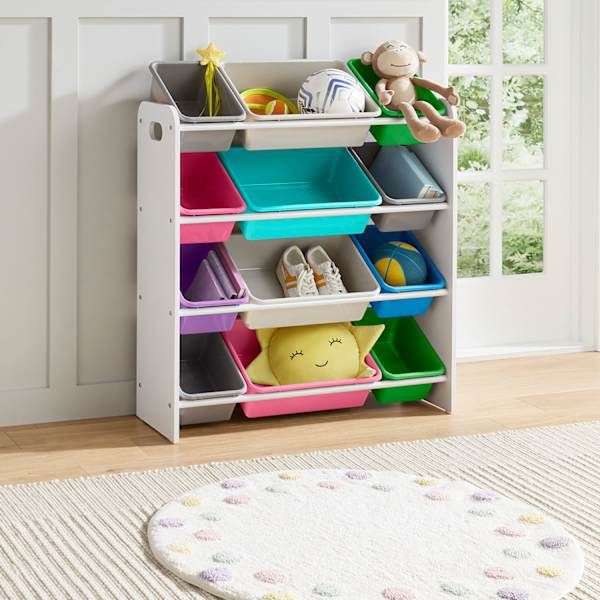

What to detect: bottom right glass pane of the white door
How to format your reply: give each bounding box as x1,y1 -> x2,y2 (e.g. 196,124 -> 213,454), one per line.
502,181 -> 544,275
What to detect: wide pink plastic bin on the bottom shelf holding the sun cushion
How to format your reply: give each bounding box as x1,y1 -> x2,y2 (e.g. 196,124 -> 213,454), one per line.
223,319 -> 381,419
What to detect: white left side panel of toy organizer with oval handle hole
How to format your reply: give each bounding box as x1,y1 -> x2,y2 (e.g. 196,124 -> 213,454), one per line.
136,102 -> 180,442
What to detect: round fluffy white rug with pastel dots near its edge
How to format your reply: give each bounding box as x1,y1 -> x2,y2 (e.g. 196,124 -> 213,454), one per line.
148,469 -> 583,600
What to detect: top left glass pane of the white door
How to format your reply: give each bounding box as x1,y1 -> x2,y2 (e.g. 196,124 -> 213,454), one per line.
448,0 -> 491,65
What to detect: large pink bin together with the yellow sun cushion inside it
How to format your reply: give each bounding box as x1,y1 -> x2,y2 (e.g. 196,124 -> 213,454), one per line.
223,320 -> 382,418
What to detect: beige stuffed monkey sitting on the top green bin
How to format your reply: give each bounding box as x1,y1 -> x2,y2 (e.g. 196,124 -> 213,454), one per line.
360,40 -> 465,143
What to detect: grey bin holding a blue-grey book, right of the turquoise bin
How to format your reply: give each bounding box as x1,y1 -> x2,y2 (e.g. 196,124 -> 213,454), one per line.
350,142 -> 446,231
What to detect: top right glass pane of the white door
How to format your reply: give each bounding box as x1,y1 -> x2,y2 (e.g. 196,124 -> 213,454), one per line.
502,0 -> 548,64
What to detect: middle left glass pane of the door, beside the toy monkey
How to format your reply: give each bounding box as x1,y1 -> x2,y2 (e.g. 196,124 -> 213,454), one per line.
452,77 -> 491,171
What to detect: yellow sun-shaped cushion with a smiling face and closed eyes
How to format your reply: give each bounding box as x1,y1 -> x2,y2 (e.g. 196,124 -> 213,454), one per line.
247,323 -> 383,385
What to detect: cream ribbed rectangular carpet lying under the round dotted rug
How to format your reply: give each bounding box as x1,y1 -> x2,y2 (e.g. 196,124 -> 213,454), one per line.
0,423 -> 600,600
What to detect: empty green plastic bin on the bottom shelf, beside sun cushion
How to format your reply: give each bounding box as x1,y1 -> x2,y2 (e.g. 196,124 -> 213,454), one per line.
355,309 -> 446,404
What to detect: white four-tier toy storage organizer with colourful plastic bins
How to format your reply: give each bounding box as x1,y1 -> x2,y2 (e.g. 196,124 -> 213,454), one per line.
137,78 -> 455,442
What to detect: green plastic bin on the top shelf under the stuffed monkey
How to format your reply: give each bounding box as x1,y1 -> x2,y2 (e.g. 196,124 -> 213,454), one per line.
347,58 -> 446,146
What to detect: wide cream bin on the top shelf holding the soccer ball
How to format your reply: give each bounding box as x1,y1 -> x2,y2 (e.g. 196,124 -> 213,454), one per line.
223,60 -> 381,150
